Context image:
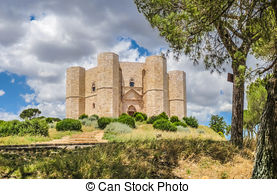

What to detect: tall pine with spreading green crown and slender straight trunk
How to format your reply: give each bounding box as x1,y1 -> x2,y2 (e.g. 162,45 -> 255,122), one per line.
134,0 -> 267,147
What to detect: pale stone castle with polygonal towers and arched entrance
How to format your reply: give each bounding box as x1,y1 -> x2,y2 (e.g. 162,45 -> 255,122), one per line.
66,52 -> 187,119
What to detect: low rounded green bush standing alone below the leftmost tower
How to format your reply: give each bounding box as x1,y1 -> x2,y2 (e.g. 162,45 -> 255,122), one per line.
56,119 -> 82,131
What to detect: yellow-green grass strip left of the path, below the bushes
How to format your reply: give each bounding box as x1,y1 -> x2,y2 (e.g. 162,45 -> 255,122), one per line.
0,126 -> 95,145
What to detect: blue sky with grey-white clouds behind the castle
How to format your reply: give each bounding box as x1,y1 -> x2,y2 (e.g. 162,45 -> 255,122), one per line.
0,0 -> 232,124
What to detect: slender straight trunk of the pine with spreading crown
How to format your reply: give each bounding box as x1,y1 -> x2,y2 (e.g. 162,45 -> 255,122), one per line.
231,61 -> 245,148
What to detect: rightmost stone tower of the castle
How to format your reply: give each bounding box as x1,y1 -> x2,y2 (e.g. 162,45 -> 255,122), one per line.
168,71 -> 187,119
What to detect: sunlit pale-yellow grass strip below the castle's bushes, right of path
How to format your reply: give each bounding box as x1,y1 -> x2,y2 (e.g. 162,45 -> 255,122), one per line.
104,123 -> 226,142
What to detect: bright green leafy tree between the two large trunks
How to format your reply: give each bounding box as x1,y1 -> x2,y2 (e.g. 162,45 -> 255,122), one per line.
243,78 -> 268,138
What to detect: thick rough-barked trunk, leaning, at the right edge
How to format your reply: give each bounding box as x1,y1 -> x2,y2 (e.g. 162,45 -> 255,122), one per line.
252,64 -> 277,179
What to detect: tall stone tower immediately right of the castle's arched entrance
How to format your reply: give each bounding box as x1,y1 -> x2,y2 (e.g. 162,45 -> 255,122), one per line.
143,56 -> 169,116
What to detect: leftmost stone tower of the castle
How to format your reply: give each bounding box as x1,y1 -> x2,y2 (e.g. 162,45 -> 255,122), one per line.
66,67 -> 85,119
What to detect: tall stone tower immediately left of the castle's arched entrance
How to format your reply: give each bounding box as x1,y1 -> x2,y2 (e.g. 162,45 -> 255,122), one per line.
97,52 -> 121,117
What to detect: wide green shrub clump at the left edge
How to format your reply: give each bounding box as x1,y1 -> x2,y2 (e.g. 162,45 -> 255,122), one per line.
0,119 -> 49,137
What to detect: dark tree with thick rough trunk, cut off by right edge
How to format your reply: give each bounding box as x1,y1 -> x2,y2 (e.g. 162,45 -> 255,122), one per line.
252,0 -> 277,179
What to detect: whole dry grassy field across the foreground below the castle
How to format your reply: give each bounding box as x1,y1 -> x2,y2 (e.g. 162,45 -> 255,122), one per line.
0,123 -> 255,179
